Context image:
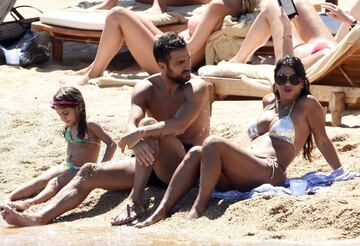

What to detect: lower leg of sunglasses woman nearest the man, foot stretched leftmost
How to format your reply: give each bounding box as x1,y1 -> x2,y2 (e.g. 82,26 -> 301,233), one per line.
136,146 -> 201,228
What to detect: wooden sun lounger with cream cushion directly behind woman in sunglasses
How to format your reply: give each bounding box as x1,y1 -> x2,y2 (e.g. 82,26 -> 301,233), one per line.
199,25 -> 360,126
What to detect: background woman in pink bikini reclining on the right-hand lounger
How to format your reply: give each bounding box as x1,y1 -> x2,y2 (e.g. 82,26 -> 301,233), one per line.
229,0 -> 360,69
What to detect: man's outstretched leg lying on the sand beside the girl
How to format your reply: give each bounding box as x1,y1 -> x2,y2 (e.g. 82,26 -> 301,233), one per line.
1,159 -> 135,226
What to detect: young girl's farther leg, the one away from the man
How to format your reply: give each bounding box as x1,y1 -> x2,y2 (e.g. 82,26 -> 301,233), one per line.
6,165 -> 65,203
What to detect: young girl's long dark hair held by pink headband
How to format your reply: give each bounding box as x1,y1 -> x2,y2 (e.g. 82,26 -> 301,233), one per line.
51,87 -> 87,138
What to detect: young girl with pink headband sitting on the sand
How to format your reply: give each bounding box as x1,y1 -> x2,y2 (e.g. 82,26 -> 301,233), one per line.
6,87 -> 116,211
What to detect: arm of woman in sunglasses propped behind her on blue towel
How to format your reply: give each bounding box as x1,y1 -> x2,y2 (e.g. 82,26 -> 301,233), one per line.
306,96 -> 341,170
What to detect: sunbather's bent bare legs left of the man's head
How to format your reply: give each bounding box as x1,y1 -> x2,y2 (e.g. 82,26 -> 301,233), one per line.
80,7 -> 161,83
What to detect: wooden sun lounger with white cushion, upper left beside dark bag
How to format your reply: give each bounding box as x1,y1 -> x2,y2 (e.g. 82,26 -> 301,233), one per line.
32,1 -> 203,61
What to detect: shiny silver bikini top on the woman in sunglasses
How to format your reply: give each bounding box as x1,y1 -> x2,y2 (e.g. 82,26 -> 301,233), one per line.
248,102 -> 295,145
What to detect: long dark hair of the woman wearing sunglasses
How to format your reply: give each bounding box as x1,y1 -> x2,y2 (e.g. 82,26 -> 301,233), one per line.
273,55 -> 314,161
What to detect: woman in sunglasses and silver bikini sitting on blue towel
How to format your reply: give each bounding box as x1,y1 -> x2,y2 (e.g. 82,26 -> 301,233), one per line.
136,7 -> 341,227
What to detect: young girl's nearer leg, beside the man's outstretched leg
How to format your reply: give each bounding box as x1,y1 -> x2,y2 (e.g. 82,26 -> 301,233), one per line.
11,169 -> 77,211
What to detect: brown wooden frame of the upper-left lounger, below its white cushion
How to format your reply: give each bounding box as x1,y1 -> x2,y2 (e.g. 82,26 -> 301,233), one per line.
31,21 -> 187,61
